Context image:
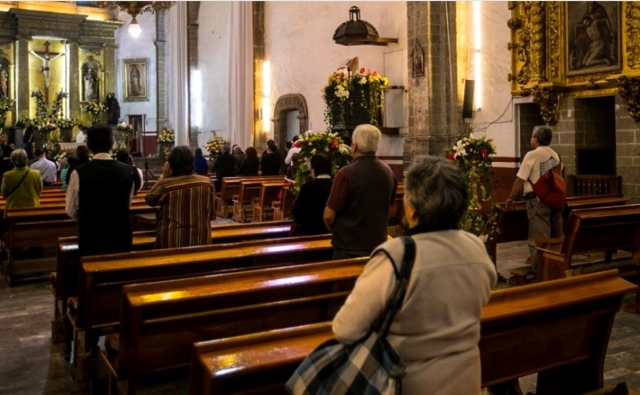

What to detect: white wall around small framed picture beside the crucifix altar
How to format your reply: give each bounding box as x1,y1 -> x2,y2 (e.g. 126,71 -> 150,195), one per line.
115,12 -> 158,131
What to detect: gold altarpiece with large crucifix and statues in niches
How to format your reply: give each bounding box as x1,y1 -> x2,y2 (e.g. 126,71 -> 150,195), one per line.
0,1 -> 121,131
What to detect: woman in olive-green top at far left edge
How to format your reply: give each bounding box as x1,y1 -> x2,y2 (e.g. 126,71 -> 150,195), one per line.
1,148 -> 42,209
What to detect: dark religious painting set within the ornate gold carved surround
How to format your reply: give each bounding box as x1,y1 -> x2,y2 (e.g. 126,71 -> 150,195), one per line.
565,1 -> 622,75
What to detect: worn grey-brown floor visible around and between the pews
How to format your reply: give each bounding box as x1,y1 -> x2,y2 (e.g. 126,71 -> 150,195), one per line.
0,242 -> 640,395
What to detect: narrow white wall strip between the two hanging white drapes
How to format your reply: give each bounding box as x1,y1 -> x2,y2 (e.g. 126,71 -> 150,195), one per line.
198,1 -> 231,147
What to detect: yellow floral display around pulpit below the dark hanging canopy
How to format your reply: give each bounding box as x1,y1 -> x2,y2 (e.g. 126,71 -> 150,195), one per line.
322,68 -> 389,130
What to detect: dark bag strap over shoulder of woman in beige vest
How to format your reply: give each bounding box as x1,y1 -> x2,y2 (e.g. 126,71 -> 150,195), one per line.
374,236 -> 416,337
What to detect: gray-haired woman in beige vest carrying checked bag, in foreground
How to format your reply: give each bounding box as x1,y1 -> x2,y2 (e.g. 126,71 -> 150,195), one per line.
333,157 -> 496,395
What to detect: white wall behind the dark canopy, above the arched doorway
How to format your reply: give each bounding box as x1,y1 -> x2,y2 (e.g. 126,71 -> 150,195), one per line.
264,1 -> 407,137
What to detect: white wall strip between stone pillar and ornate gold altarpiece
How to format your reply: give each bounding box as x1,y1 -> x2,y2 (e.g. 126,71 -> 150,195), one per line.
469,1 -> 516,159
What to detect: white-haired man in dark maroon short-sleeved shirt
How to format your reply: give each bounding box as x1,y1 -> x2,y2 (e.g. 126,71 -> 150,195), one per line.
324,125 -> 398,259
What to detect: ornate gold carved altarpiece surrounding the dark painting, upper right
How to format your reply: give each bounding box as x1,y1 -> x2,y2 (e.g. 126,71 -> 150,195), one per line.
507,1 -> 640,125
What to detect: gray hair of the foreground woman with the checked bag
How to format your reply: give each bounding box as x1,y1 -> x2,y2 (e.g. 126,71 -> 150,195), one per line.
404,156 -> 469,230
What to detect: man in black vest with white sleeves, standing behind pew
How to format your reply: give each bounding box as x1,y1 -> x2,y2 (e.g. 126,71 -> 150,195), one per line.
66,126 -> 134,256
